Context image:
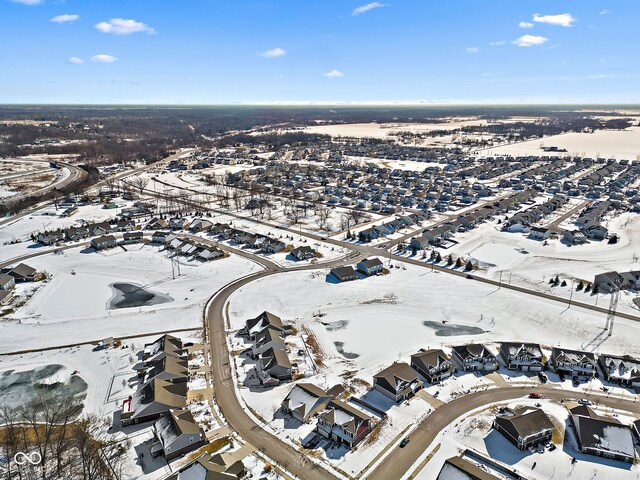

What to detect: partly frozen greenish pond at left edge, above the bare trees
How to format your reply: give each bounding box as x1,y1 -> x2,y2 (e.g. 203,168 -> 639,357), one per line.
0,365 -> 87,408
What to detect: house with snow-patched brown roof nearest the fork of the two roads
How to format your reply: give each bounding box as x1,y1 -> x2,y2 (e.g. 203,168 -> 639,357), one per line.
316,400 -> 373,448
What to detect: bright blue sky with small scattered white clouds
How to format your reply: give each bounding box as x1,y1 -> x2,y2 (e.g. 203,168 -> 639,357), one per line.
0,0 -> 640,104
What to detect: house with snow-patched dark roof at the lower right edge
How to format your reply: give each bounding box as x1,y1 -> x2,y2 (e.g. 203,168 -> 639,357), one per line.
569,405 -> 636,463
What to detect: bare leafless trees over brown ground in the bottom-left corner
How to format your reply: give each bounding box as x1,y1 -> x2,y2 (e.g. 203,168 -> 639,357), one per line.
0,393 -> 129,480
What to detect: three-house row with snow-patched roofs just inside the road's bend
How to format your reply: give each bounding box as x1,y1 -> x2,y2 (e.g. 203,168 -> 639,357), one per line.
238,311 -> 293,387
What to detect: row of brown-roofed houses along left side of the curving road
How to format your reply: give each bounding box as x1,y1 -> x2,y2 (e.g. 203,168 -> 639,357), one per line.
120,335 -> 207,461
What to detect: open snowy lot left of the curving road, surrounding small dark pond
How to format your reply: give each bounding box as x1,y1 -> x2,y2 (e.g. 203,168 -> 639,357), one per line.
0,244 -> 260,353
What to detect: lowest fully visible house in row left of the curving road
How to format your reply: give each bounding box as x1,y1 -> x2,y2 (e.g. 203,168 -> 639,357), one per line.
151,408 -> 207,462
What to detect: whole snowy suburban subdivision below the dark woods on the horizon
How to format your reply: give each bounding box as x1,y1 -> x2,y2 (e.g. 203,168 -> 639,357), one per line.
0,102 -> 640,480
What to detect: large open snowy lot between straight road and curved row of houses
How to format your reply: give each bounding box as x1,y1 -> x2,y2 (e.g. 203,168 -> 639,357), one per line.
229,266 -> 640,383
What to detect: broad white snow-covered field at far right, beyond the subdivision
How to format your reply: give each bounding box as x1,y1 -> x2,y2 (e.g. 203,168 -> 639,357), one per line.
481,127 -> 640,160
